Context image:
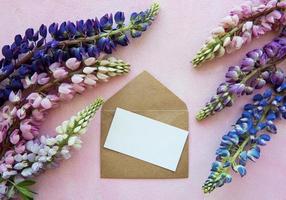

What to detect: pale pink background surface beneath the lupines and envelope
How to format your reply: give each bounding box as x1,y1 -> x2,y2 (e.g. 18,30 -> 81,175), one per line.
0,0 -> 286,200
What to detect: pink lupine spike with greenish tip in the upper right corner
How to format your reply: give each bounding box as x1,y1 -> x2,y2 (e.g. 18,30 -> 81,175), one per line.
192,0 -> 286,67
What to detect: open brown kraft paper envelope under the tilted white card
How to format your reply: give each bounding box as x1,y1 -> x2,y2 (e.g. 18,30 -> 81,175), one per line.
100,72 -> 188,179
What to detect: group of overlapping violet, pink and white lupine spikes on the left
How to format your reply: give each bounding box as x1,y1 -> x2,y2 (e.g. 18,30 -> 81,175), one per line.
0,4 -> 159,199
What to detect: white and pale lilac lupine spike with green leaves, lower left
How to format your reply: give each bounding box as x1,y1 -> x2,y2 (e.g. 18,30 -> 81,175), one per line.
0,98 -> 103,199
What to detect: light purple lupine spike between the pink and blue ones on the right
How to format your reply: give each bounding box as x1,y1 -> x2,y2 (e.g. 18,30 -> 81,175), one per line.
196,30 -> 286,120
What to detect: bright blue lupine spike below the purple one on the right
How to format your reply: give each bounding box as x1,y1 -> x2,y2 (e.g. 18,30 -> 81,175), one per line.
203,82 -> 286,193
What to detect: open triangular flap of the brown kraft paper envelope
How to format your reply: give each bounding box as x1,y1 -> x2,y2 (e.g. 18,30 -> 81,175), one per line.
102,71 -> 187,111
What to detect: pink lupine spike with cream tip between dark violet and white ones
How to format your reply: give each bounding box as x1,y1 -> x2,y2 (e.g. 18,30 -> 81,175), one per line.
0,57 -> 130,153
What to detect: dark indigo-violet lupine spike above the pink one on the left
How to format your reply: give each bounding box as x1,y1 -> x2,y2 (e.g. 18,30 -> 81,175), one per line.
0,3 -> 159,106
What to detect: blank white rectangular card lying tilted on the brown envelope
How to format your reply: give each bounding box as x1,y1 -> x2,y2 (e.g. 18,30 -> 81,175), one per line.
104,108 -> 188,171
